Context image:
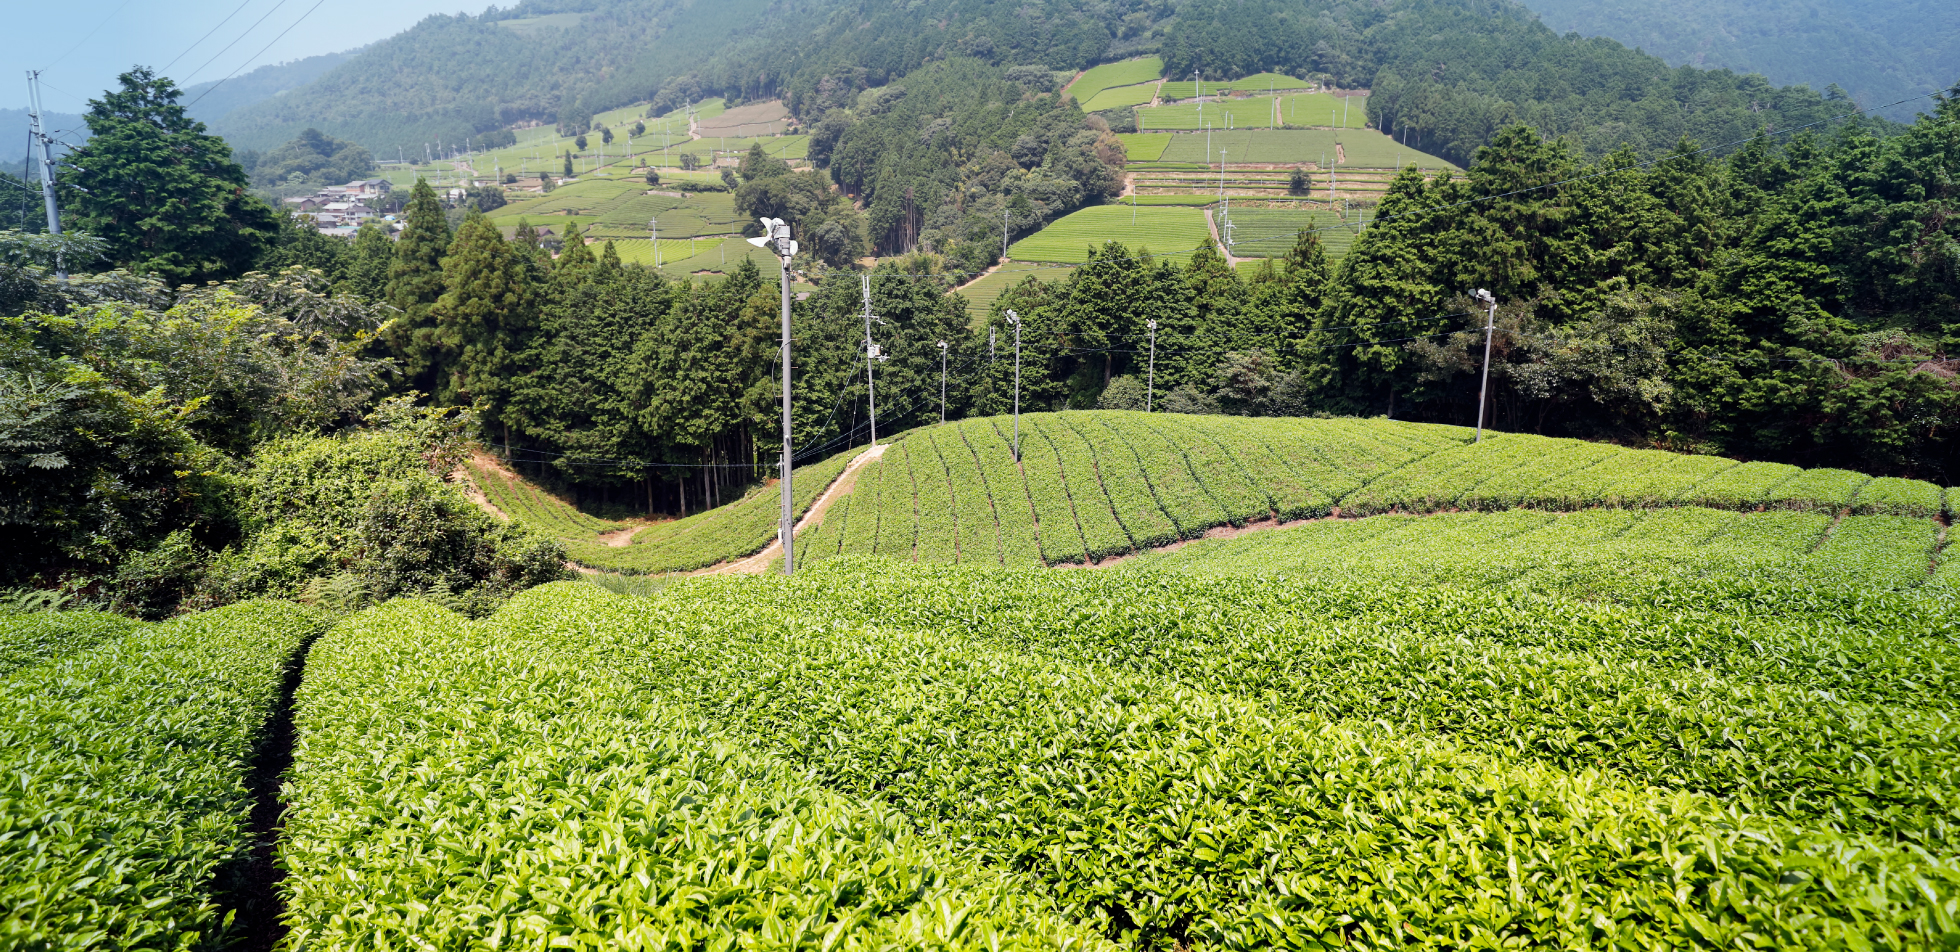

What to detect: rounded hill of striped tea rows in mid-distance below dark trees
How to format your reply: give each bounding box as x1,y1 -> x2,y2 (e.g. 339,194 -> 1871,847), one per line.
666,411 -> 1940,586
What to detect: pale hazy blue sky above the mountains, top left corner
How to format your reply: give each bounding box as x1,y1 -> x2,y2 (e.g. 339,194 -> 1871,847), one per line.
0,0 -> 493,112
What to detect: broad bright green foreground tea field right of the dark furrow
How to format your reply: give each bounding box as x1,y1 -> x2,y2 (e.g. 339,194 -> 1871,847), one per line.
248,552 -> 1960,950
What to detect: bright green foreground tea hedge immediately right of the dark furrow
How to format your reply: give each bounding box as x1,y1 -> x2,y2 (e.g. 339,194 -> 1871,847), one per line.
280,584 -> 1102,950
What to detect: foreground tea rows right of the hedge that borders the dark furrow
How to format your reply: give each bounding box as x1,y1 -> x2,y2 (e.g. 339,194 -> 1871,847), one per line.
566,562 -> 1952,948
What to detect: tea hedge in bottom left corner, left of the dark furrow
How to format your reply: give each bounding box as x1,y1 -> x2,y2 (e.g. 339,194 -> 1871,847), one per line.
0,601 -> 325,950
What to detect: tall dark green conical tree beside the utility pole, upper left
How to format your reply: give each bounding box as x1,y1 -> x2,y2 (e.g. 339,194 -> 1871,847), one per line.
59,67 -> 276,284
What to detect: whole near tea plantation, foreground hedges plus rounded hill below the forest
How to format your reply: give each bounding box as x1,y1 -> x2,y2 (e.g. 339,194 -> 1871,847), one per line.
0,411 -> 1960,952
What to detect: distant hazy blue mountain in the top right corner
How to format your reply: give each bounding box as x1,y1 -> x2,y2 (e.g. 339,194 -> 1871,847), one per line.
1527,0 -> 1960,119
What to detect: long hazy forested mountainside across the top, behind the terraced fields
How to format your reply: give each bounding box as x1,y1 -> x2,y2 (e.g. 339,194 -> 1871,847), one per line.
195,0 -> 1897,176
